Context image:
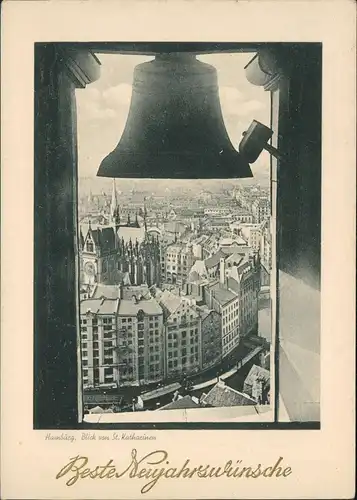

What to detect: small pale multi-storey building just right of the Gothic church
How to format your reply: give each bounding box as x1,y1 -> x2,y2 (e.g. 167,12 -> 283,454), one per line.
161,243 -> 195,285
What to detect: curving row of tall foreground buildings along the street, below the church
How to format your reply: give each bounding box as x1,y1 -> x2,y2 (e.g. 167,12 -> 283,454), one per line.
81,248 -> 260,387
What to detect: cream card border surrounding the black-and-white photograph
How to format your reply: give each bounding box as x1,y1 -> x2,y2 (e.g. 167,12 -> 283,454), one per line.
1,0 -> 356,499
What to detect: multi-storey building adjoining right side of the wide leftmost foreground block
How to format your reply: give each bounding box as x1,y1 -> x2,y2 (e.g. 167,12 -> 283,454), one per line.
157,290 -> 201,378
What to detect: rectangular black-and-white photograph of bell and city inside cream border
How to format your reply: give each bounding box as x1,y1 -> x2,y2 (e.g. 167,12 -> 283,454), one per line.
34,42 -> 322,426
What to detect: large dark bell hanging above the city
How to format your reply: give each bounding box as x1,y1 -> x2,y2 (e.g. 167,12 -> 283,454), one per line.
97,53 -> 252,179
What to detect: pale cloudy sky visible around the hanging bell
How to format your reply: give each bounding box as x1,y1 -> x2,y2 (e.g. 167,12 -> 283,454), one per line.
76,53 -> 270,190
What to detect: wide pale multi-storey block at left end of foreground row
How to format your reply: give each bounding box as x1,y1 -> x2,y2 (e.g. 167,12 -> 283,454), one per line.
81,296 -> 164,387
